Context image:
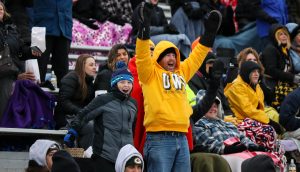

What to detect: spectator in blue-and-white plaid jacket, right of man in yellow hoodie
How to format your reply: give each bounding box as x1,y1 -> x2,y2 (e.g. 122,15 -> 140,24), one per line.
194,90 -> 265,154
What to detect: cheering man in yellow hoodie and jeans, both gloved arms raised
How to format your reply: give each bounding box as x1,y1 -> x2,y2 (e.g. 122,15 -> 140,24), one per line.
136,3 -> 221,172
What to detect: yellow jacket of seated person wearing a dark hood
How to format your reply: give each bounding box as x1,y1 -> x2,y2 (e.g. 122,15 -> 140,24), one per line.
224,75 -> 269,124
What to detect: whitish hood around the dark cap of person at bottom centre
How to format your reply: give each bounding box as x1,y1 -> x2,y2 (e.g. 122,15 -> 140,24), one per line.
115,144 -> 144,172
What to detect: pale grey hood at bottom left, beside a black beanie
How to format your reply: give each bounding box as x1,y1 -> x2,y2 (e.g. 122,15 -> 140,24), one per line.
29,139 -> 59,167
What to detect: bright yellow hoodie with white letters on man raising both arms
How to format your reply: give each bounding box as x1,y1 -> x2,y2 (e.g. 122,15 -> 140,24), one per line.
136,39 -> 210,132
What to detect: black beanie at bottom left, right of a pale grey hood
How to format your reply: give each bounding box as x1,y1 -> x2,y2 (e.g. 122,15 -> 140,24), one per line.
51,150 -> 80,172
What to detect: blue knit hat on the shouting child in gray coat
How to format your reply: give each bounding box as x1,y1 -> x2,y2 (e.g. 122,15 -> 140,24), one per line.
110,61 -> 133,87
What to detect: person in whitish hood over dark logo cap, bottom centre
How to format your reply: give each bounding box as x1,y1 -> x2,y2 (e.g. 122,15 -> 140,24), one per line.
115,144 -> 144,172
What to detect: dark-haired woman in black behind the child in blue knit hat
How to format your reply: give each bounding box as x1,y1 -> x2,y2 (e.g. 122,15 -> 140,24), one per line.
95,44 -> 129,92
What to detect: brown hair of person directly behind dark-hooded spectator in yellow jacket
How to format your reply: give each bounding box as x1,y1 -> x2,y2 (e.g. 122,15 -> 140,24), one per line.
237,47 -> 265,74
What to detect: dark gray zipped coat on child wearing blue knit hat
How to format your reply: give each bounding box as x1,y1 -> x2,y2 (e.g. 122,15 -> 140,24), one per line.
71,90 -> 137,163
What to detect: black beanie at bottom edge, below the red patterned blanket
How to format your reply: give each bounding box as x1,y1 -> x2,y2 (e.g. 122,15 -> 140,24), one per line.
242,155 -> 276,172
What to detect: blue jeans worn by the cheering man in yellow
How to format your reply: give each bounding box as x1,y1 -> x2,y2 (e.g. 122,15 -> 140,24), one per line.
144,133 -> 191,172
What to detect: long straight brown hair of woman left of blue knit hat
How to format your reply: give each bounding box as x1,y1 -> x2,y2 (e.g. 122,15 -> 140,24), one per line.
75,54 -> 95,101
